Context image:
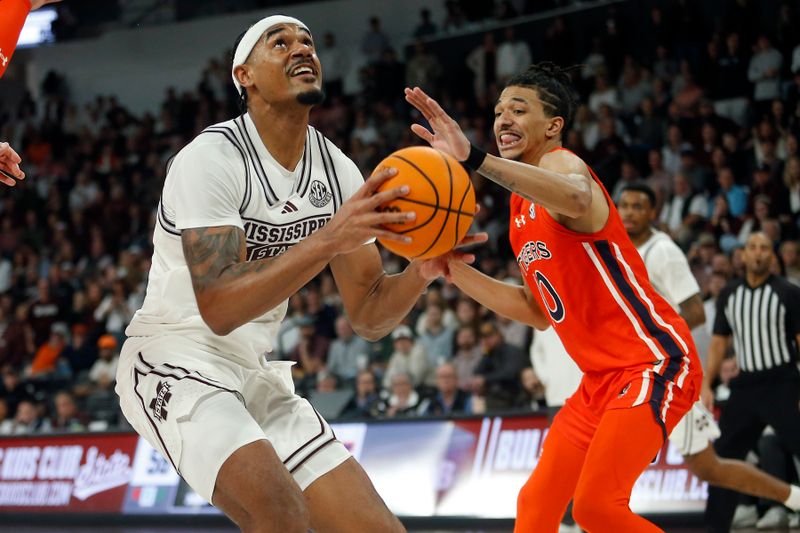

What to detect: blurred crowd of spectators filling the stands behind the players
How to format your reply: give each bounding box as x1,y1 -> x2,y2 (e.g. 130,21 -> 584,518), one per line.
0,0 -> 800,434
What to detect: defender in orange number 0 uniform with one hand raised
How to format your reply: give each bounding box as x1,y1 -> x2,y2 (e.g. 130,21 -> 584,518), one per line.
406,63 -> 702,533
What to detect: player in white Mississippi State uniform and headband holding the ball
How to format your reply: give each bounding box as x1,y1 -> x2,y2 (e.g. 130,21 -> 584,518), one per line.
116,16 -> 478,533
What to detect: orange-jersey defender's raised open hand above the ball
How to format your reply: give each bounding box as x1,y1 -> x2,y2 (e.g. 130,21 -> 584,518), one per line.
405,87 -> 470,161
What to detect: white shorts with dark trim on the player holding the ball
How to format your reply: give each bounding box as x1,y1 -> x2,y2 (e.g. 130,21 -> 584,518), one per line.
116,336 -> 350,502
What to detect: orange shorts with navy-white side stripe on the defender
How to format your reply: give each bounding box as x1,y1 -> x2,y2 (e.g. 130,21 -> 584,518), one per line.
553,370 -> 700,450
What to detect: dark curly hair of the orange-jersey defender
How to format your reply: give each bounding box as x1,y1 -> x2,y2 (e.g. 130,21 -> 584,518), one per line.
506,61 -> 580,137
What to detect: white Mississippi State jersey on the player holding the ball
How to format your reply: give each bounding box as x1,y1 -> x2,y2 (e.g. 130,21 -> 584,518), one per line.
126,113 -> 363,363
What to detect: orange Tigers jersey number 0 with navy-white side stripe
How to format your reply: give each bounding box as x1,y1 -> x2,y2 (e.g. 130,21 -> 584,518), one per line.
509,149 -> 702,405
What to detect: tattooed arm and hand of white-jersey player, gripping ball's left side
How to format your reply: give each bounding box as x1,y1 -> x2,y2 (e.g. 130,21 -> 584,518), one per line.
181,169 -> 409,335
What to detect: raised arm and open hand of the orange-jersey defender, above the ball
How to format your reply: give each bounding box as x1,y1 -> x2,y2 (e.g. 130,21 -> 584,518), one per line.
405,87 -> 596,218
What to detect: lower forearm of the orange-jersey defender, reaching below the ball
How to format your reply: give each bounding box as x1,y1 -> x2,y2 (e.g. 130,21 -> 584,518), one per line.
448,260 -> 550,330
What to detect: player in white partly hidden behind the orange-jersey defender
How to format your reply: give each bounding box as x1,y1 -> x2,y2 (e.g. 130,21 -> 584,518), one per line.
617,184 -> 800,511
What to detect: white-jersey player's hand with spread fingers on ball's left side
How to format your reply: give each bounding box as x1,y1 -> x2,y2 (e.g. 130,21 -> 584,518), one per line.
317,167 -> 417,254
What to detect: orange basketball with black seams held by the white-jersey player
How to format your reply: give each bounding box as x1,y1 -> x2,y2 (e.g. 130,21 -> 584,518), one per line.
378,146 -> 475,259
